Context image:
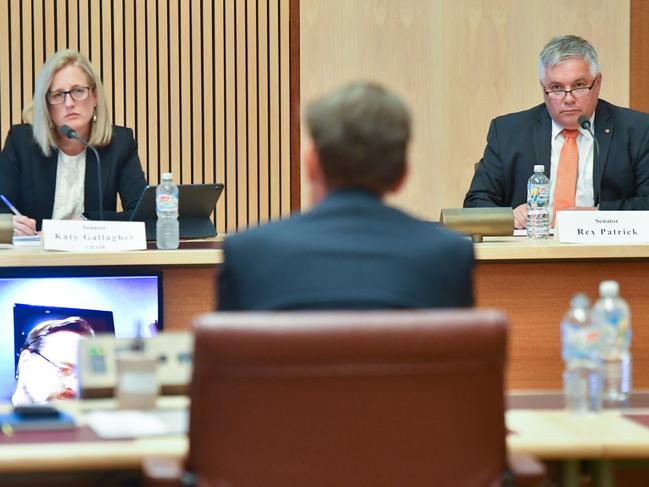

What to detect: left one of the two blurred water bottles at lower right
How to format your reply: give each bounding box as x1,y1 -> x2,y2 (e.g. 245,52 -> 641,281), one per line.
561,294 -> 604,414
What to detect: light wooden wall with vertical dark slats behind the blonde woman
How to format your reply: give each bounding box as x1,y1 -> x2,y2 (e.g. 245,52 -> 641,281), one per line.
0,0 -> 292,233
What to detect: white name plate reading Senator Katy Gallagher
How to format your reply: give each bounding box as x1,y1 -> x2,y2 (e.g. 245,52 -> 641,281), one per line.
42,220 -> 146,252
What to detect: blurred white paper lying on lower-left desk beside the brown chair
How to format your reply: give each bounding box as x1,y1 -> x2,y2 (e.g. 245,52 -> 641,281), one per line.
86,409 -> 189,439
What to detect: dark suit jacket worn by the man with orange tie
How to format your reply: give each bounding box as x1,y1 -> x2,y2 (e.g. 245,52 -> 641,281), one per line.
464,100 -> 649,210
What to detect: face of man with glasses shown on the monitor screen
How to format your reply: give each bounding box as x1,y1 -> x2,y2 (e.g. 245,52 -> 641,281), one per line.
12,331 -> 82,405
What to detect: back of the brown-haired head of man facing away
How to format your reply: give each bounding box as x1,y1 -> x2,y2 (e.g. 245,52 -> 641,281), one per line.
306,82 -> 410,195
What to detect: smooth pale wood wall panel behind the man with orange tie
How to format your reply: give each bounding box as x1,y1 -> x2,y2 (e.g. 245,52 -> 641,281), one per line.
300,0 -> 630,220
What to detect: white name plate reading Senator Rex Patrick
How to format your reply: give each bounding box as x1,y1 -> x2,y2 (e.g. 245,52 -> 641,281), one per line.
555,211 -> 649,244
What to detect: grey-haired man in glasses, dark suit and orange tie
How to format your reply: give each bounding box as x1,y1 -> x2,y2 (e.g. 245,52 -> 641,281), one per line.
464,35 -> 649,228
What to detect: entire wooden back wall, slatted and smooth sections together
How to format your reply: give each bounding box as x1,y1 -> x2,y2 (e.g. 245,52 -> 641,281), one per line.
0,0 -> 649,232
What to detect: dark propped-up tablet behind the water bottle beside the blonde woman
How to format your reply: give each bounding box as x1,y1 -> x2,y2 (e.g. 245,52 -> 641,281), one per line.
130,183 -> 223,240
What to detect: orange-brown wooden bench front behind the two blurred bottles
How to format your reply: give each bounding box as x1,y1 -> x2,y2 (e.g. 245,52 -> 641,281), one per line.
475,259 -> 649,389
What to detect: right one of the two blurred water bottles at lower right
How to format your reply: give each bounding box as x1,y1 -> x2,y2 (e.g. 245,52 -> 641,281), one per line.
593,281 -> 631,403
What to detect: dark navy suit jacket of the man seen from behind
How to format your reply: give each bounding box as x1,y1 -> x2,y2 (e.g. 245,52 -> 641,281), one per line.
218,189 -> 474,310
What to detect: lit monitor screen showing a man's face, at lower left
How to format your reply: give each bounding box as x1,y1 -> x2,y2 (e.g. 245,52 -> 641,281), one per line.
0,270 -> 162,402
